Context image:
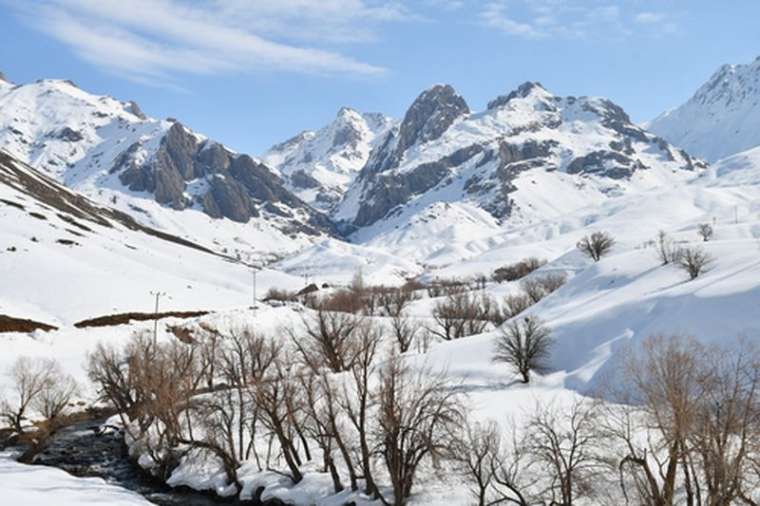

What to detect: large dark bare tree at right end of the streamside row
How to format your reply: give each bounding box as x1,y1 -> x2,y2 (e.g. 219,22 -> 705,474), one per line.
374,357 -> 463,506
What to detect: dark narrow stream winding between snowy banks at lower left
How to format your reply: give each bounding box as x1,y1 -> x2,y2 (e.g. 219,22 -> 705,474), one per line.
34,420 -> 251,506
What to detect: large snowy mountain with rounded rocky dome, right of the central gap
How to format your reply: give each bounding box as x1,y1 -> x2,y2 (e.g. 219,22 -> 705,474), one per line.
334,82 -> 705,262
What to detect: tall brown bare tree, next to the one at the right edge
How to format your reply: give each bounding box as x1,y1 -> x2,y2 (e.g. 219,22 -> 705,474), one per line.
603,336 -> 705,506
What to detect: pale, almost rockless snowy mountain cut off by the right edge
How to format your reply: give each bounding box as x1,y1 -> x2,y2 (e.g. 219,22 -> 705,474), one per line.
648,57 -> 760,162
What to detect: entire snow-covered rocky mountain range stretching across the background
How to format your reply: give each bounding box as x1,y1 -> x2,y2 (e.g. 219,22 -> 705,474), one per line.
0,59 -> 760,256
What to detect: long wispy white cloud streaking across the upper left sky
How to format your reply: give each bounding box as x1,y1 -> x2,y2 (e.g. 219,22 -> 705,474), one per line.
17,0 -> 406,85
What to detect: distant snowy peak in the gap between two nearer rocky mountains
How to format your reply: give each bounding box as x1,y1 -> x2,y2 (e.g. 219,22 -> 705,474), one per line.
262,107 -> 395,210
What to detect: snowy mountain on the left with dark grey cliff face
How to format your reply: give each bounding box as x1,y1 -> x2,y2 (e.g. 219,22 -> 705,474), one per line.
0,80 -> 333,253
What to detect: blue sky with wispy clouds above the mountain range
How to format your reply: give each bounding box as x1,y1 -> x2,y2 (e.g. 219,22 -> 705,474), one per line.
0,0 -> 760,154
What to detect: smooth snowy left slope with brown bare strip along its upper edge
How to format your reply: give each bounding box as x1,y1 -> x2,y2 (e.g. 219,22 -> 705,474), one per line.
0,152 -> 301,326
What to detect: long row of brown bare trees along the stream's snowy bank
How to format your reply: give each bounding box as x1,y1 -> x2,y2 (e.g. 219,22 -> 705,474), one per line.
83,310 -> 464,505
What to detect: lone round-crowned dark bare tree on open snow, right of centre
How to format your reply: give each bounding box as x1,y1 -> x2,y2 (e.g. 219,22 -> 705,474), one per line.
493,316 -> 554,383
